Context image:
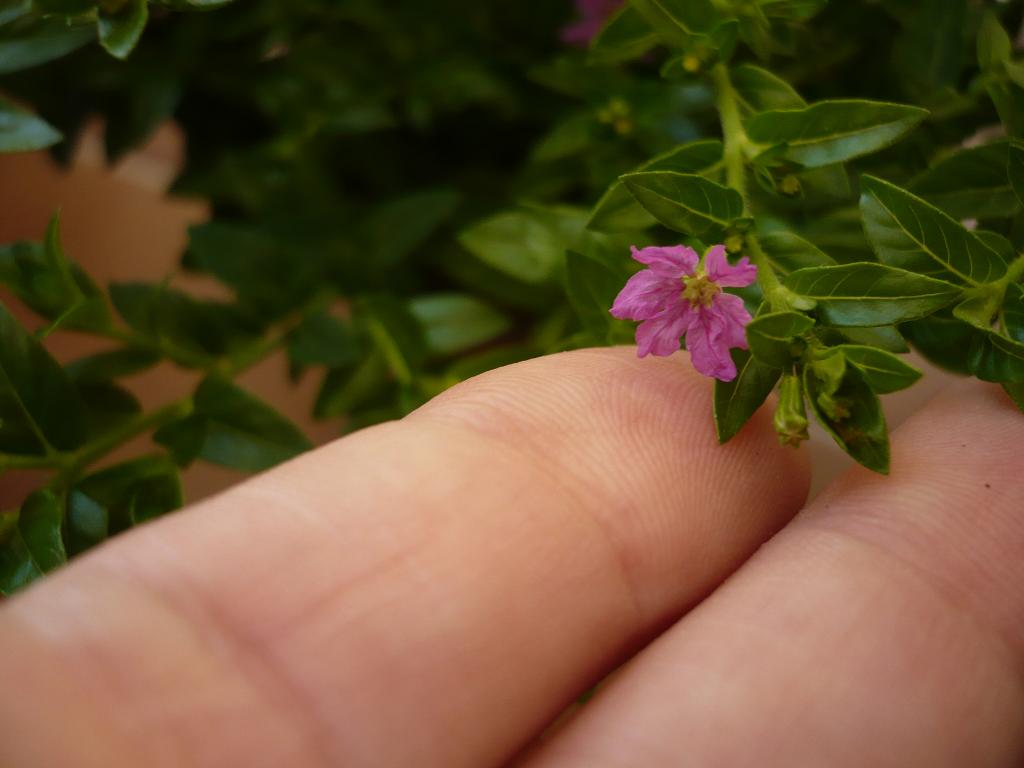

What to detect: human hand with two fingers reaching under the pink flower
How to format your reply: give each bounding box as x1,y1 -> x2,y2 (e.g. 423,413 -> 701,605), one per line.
0,349 -> 1024,768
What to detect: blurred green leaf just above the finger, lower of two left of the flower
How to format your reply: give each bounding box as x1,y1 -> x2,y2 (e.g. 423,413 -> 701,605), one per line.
409,293 -> 512,356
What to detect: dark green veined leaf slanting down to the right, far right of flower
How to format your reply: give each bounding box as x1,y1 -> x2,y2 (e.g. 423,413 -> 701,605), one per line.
860,176 -> 1007,285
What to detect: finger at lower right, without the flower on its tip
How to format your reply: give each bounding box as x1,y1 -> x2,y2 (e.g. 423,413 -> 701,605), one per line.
519,383 -> 1024,768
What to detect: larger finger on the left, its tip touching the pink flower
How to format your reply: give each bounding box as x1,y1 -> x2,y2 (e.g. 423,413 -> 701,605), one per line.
0,349 -> 808,768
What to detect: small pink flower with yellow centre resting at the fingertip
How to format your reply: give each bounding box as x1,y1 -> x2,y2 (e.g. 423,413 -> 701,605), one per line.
611,246 -> 758,381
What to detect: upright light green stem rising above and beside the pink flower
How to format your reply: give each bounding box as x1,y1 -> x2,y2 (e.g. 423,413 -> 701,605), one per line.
712,63 -> 788,309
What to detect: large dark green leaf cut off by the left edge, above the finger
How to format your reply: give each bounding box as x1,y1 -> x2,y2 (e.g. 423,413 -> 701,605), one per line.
0,304 -> 85,454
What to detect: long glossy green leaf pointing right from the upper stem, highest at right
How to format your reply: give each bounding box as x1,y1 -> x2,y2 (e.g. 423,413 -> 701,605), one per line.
746,99 -> 928,168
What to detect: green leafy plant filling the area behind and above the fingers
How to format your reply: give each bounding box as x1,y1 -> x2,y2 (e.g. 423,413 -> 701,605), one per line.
0,0 -> 1024,593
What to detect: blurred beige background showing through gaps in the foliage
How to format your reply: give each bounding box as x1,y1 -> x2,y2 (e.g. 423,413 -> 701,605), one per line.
0,124 -> 950,507
